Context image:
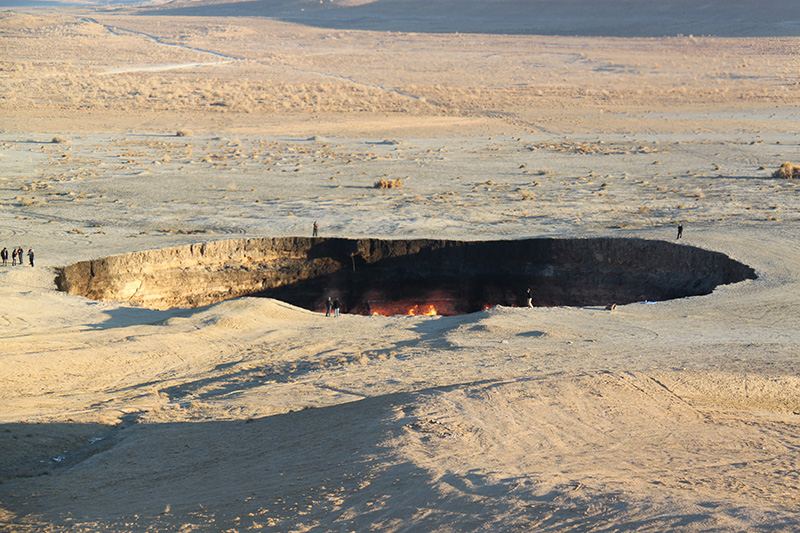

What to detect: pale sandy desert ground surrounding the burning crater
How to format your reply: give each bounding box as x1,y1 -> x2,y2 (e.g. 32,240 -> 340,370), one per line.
0,1 -> 800,532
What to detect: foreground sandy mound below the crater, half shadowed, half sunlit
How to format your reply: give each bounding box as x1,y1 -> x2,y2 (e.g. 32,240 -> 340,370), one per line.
9,372 -> 800,531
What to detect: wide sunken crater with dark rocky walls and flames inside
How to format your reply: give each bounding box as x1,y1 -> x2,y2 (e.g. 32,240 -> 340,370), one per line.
56,237 -> 756,314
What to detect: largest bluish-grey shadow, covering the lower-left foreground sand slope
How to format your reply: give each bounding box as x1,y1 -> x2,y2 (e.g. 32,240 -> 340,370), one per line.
0,383 -> 707,531
